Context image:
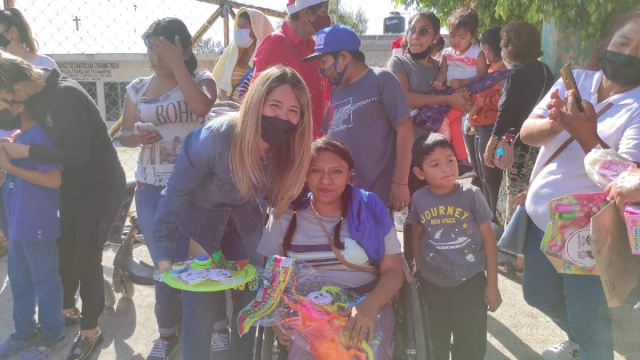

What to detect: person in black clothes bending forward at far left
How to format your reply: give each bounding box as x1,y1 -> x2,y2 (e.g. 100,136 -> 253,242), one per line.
0,53 -> 125,360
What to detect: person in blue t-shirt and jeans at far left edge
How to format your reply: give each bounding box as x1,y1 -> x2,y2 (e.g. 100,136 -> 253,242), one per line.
0,100 -> 67,359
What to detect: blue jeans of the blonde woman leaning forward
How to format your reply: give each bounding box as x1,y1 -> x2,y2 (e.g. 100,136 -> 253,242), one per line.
181,222 -> 263,360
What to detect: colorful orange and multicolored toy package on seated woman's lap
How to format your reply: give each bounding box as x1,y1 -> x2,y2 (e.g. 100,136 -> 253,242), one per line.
238,256 -> 381,360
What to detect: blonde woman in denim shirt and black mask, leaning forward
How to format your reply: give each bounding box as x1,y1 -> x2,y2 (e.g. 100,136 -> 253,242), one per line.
153,66 -> 313,359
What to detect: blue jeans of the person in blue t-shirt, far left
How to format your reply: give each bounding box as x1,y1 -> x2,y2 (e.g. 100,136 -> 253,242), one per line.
8,241 -> 64,341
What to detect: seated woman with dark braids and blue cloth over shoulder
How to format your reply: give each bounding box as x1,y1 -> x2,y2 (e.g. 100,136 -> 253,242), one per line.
258,137 -> 403,360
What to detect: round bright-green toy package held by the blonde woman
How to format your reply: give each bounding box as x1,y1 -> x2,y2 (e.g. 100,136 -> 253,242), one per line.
162,251 -> 257,292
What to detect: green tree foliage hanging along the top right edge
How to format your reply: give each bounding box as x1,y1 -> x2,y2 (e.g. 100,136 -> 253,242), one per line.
393,0 -> 639,39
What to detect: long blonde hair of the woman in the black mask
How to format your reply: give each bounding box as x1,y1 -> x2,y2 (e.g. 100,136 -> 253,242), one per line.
229,65 -> 313,217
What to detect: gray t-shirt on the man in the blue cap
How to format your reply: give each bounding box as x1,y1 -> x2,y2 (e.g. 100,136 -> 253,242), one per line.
322,68 -> 409,204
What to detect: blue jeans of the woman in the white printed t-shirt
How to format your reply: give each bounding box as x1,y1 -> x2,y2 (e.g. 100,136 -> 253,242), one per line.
136,184 -> 180,336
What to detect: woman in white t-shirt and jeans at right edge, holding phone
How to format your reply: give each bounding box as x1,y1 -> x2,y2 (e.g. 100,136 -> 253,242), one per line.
520,9 -> 640,360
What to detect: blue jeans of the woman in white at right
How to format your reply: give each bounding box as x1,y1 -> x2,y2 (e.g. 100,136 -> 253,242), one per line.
522,215 -> 613,360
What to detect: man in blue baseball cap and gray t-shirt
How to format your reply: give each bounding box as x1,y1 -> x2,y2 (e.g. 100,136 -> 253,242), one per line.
303,25 -> 414,215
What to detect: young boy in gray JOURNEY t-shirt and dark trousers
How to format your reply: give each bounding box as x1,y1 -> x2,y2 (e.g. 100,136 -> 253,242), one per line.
409,133 -> 502,360
